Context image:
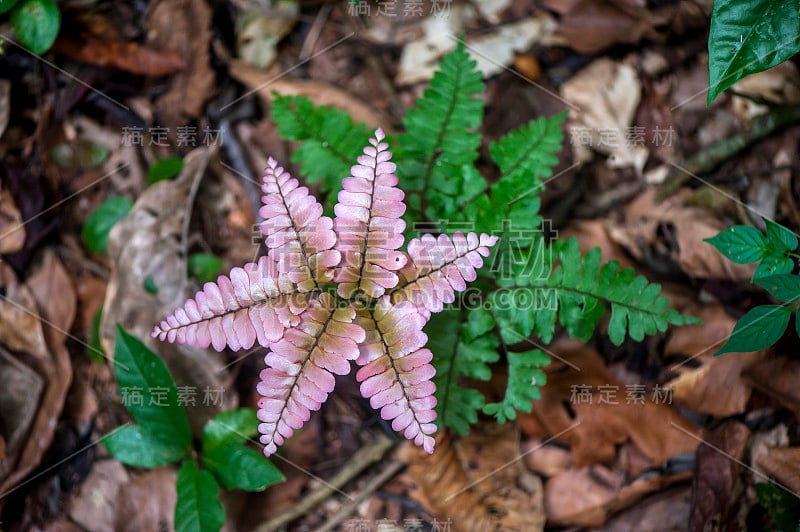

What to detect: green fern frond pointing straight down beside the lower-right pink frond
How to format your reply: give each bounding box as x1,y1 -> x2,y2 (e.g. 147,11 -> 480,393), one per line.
425,309 -> 500,435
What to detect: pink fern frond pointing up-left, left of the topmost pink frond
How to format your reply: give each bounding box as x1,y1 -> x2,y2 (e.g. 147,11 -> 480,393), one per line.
258,157 -> 341,292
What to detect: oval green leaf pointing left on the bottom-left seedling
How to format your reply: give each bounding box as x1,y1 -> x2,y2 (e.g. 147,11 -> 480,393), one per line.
102,425 -> 187,469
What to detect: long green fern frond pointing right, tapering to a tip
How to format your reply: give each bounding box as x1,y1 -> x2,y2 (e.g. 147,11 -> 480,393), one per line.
493,237 -> 700,345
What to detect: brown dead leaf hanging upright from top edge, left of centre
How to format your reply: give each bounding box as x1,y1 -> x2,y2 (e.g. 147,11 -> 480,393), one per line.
147,0 -> 216,128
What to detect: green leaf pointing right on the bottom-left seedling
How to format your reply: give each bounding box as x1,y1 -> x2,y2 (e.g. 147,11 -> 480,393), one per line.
203,444 -> 286,491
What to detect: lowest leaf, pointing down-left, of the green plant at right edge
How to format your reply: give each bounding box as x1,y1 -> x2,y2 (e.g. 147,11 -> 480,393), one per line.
714,305 -> 792,356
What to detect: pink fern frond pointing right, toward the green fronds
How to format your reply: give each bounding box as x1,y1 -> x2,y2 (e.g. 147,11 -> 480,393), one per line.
391,233 -> 497,315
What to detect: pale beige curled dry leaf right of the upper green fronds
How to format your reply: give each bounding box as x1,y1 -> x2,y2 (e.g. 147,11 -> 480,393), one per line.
561,58 -> 648,174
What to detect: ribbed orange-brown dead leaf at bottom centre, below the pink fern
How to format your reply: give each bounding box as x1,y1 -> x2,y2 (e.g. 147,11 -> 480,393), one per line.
409,422 -> 545,532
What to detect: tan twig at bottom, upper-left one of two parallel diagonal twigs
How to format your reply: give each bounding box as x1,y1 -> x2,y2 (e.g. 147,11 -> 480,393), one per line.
256,434 -> 394,532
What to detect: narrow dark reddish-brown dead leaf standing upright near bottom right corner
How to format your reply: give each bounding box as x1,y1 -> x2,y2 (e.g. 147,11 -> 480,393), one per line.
689,421 -> 750,531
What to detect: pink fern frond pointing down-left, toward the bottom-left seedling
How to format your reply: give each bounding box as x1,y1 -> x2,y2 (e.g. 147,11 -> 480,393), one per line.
258,293 -> 365,456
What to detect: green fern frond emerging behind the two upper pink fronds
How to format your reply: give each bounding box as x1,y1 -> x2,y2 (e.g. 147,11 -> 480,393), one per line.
272,95 -> 369,205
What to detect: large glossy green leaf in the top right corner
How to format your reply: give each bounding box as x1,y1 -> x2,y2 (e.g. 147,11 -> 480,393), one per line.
708,0 -> 800,104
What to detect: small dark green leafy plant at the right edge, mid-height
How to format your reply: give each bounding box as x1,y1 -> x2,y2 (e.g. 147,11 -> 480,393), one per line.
706,219 -> 800,355
